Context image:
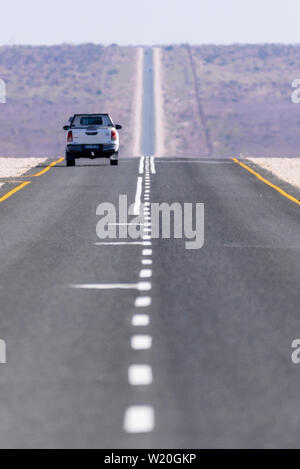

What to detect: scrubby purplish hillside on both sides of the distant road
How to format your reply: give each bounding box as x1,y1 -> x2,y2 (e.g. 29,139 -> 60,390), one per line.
0,44 -> 300,157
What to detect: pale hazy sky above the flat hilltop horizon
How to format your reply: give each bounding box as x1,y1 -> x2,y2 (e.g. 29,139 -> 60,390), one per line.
0,0 -> 300,44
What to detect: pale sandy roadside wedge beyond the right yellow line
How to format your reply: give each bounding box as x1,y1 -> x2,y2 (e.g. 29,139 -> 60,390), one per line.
247,158 -> 300,188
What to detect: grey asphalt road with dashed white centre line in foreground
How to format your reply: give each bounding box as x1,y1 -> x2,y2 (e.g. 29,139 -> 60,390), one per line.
0,49 -> 300,448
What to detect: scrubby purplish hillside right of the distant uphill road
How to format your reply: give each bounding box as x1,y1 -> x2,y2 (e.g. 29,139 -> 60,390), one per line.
163,45 -> 300,157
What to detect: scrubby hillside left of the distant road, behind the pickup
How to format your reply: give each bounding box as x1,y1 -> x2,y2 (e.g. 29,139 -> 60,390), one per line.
0,44 -> 136,157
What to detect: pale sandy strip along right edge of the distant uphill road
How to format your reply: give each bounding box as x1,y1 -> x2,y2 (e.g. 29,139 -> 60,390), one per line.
153,47 -> 165,157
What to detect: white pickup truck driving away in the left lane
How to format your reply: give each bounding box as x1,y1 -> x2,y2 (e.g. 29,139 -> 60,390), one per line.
64,114 -> 122,166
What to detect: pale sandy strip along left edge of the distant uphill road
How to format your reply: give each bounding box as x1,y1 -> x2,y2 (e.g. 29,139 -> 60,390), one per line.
133,47 -> 144,156
